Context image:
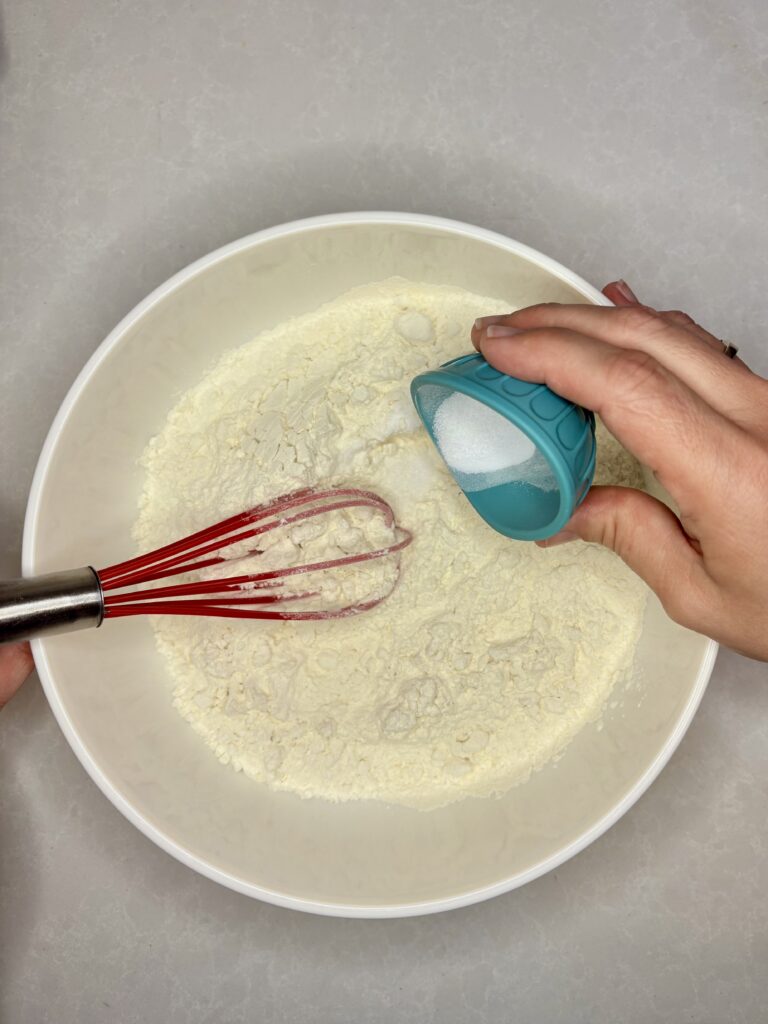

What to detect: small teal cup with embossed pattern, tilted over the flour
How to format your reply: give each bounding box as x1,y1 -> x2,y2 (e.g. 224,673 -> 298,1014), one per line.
411,353 -> 597,541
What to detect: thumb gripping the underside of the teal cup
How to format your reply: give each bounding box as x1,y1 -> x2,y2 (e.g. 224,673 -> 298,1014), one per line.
537,486 -> 710,626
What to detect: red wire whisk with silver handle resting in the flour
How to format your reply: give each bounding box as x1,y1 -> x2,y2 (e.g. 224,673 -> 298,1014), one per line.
0,487 -> 412,643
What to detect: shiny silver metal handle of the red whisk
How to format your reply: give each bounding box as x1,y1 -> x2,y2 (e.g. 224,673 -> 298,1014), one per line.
0,565 -> 104,643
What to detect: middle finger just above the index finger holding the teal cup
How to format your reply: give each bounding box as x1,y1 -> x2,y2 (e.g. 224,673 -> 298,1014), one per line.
478,303 -> 755,426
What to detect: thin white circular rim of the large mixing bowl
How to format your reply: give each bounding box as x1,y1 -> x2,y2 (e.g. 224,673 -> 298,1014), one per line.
22,211 -> 718,919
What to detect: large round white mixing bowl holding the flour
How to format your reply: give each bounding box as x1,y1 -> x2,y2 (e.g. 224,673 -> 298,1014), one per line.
24,213 -> 717,918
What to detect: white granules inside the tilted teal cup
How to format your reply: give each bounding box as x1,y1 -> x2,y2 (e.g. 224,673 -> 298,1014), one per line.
432,391 -> 537,474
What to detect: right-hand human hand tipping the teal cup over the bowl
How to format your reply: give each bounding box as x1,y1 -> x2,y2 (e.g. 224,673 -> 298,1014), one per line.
472,282 -> 768,660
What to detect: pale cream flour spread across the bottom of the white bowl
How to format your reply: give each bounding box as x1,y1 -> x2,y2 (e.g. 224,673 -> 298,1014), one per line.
136,279 -> 646,808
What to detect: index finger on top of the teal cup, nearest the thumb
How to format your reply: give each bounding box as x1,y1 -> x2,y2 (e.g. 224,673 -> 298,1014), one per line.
480,329 -> 742,515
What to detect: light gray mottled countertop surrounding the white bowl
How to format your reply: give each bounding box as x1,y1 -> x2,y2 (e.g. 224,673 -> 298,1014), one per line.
0,0 -> 768,1024
